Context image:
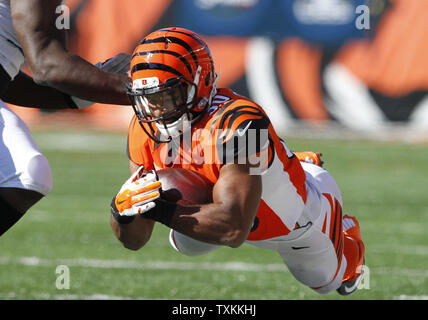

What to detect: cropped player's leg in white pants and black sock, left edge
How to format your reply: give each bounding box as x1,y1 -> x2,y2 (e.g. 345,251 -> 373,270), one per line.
0,100 -> 53,233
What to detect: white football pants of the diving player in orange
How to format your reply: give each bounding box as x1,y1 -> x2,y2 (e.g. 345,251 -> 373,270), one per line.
169,163 -> 347,294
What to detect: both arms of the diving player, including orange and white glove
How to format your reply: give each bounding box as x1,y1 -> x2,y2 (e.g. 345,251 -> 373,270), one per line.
111,164 -> 262,250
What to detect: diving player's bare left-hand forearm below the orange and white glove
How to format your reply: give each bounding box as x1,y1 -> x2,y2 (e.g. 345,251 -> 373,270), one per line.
110,161 -> 155,250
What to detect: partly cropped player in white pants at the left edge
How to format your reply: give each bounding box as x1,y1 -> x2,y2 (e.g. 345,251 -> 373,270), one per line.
0,0 -> 129,236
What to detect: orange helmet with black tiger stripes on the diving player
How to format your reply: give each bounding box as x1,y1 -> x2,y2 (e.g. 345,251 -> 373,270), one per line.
128,27 -> 217,142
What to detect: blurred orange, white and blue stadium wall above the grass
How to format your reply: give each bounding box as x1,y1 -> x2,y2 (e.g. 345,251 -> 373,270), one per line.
6,0 -> 428,140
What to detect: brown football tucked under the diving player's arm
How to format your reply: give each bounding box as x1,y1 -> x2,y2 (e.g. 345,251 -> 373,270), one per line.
157,168 -> 214,205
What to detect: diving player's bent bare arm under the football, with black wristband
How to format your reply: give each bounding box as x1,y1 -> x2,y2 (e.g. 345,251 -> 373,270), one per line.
170,164 -> 262,248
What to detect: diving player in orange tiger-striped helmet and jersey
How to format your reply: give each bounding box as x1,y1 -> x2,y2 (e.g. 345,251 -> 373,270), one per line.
111,28 -> 364,294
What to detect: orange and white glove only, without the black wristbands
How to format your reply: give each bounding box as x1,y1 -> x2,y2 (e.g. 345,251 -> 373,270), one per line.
114,167 -> 162,217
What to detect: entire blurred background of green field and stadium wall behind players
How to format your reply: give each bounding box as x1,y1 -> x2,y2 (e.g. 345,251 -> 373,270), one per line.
0,0 -> 428,300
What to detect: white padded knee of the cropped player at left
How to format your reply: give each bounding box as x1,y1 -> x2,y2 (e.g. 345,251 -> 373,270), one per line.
21,154 -> 53,195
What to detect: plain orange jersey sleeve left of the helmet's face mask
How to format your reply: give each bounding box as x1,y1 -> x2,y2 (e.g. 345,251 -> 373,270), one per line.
126,116 -> 154,170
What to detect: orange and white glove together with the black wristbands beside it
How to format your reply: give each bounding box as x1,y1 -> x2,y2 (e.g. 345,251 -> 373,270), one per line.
111,167 -> 177,225
